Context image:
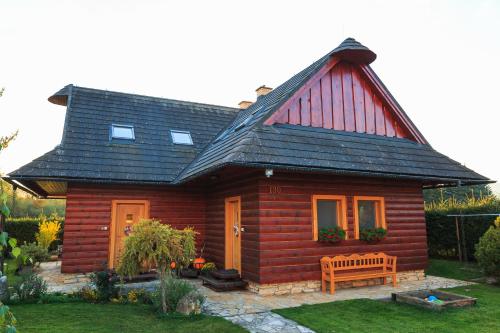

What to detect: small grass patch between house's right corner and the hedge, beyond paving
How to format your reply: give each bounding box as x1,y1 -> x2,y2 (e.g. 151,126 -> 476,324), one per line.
425,259 -> 484,281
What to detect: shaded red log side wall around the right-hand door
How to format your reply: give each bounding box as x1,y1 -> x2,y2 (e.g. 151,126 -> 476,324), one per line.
205,175 -> 259,282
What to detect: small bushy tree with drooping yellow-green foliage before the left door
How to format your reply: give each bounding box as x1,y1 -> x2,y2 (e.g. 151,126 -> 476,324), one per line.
117,219 -> 196,312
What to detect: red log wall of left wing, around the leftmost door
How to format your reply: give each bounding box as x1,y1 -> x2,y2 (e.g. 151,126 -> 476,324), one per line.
61,184 -> 205,273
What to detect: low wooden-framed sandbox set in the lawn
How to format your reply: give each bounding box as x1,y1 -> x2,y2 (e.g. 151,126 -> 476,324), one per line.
392,290 -> 477,311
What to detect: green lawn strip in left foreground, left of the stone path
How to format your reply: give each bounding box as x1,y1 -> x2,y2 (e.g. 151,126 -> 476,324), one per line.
11,303 -> 246,333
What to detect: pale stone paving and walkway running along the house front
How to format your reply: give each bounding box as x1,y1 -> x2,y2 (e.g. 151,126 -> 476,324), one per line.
39,263 -> 473,333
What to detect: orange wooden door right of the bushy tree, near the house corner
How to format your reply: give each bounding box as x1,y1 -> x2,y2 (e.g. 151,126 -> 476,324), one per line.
225,197 -> 241,273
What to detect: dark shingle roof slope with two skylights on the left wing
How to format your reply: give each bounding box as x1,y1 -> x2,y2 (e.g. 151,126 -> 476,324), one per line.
10,86 -> 238,183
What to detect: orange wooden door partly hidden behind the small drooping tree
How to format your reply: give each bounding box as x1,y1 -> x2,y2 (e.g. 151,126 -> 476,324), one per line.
109,200 -> 149,268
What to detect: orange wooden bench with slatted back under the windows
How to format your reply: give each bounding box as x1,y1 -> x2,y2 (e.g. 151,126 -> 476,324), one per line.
321,252 -> 397,295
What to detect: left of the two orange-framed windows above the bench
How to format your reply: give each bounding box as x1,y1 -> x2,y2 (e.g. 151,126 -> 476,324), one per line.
312,195 -> 347,240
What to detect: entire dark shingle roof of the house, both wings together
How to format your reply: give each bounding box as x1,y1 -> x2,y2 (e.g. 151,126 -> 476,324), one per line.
10,38 -> 489,188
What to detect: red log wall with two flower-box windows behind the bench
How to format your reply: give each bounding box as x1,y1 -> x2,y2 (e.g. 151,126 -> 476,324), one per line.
259,175 -> 427,284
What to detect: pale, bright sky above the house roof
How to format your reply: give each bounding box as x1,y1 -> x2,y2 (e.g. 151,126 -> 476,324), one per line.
0,0 -> 500,193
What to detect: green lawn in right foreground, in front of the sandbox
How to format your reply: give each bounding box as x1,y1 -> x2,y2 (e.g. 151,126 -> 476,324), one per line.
275,284 -> 500,333
